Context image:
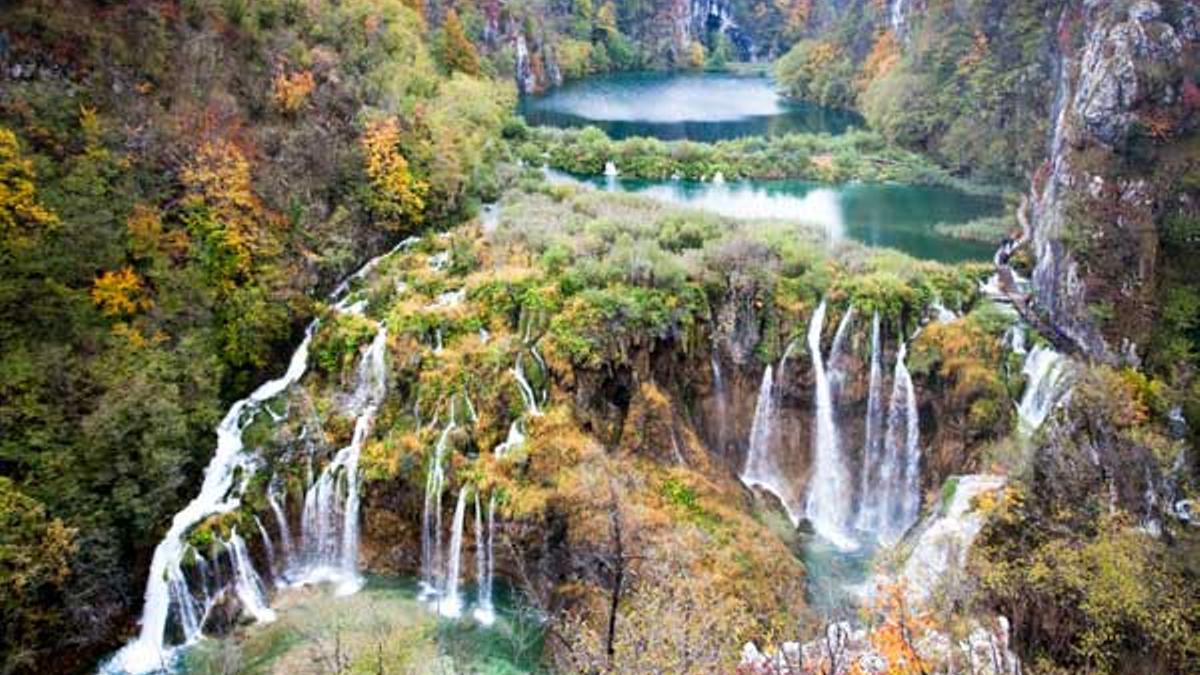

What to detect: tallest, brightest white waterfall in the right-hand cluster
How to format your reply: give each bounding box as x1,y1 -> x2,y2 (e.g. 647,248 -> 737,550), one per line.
804,300 -> 857,550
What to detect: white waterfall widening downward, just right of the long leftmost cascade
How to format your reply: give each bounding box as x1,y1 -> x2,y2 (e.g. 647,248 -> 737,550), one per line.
295,325 -> 388,595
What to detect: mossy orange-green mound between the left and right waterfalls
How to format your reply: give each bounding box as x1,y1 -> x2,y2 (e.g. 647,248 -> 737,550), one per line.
192,176 -> 985,671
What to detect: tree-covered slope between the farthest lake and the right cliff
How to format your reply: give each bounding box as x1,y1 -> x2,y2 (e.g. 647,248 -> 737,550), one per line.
775,0 -> 1063,180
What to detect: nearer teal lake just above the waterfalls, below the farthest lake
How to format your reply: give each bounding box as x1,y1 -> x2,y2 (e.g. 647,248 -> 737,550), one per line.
547,171 -> 1003,263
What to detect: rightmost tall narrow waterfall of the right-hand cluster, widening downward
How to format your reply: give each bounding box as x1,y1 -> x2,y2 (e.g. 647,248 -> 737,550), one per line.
876,342 -> 920,543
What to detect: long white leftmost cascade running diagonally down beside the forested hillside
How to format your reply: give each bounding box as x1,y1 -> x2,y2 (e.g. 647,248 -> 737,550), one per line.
103,322 -> 317,673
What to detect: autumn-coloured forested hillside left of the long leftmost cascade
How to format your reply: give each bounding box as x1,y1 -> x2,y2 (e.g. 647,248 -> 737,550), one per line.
0,1 -> 511,671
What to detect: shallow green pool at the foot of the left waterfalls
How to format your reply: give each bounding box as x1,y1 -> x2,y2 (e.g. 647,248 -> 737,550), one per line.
179,577 -> 542,675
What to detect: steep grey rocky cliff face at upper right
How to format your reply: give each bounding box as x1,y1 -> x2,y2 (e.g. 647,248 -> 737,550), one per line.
1027,0 -> 1198,363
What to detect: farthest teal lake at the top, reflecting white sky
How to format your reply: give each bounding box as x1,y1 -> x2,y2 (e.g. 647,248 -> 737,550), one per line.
520,72 -> 863,142
